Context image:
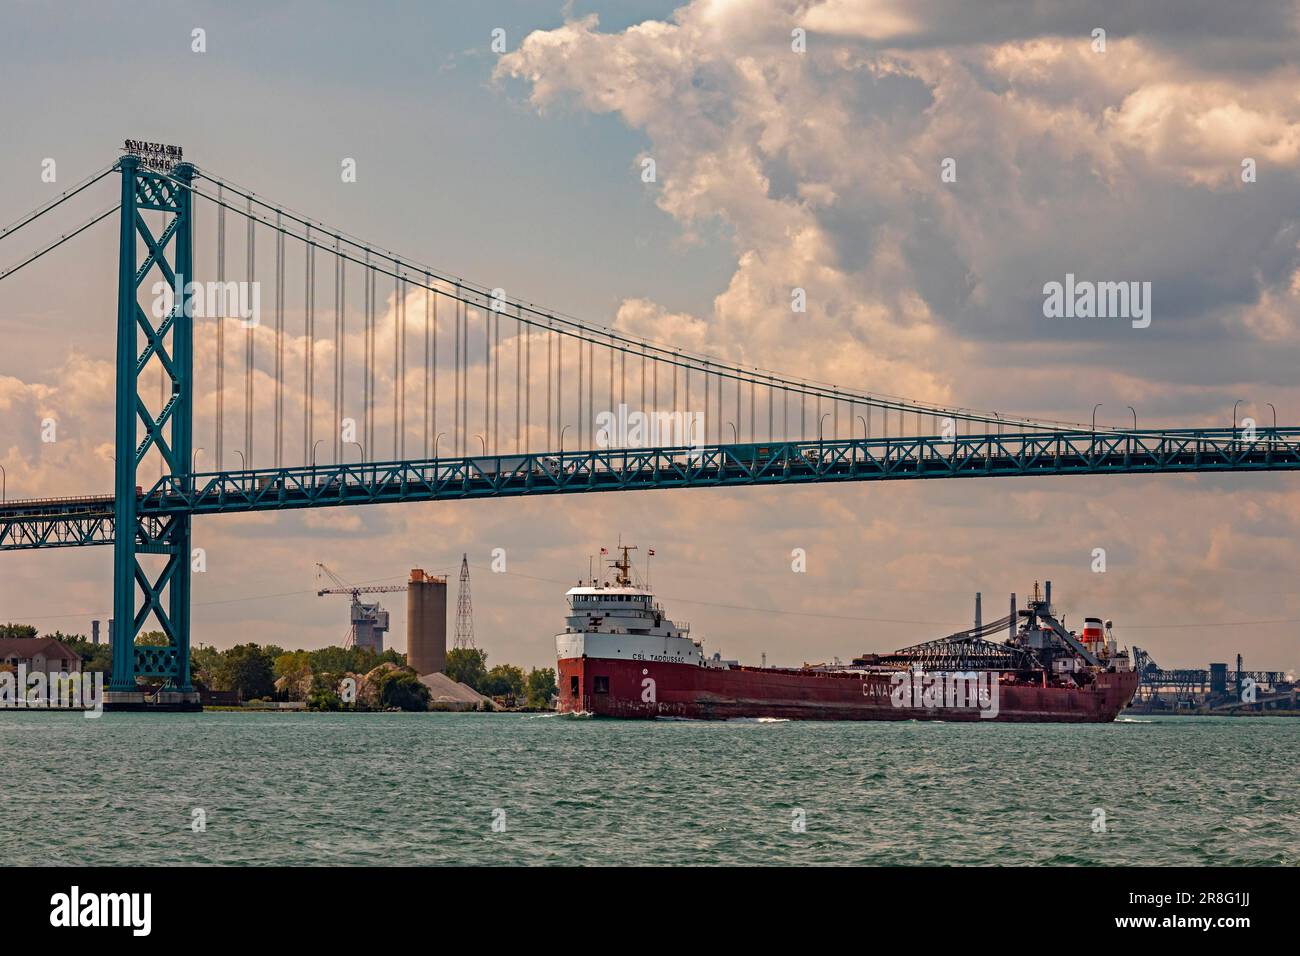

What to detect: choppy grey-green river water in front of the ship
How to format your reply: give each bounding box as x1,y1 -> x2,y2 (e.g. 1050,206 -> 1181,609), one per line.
0,713 -> 1300,865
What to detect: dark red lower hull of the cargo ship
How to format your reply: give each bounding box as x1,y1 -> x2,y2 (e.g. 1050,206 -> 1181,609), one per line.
558,657 -> 1138,723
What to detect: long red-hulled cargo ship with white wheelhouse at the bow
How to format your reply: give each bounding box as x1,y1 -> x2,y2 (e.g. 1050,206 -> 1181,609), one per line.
555,545 -> 1139,723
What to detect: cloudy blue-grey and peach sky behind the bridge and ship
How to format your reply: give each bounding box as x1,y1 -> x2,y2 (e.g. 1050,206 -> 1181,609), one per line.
0,0 -> 1300,669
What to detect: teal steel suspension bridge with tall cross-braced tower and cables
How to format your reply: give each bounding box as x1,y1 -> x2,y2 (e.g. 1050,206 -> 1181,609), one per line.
0,144 -> 1300,706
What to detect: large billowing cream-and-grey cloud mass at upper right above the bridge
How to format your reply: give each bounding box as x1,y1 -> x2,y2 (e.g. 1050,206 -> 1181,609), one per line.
497,0 -> 1300,418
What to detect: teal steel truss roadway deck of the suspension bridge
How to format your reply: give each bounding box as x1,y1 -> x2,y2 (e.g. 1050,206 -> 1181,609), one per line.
0,428 -> 1300,550
